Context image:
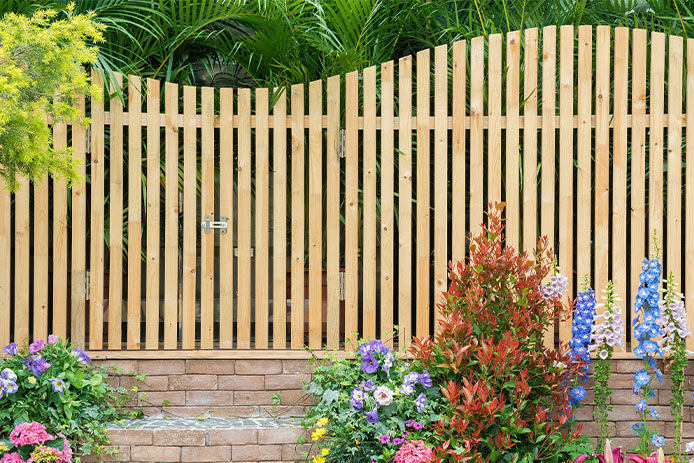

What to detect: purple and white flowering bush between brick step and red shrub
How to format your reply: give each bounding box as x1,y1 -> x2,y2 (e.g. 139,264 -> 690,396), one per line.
300,340 -> 441,463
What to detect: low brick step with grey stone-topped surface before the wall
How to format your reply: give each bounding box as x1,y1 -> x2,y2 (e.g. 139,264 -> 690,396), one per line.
101,418 -> 310,463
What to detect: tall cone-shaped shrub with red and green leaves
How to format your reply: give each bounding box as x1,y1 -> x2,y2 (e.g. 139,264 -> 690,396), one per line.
412,204 -> 580,462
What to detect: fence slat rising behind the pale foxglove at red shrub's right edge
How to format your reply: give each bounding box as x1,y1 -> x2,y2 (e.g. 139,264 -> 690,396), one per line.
540,26 -> 569,347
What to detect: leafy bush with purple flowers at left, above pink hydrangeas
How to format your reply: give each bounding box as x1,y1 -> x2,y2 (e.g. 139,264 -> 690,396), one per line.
0,335 -> 135,454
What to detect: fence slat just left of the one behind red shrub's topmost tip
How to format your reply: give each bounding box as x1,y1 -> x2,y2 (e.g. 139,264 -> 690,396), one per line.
470,37 -> 484,236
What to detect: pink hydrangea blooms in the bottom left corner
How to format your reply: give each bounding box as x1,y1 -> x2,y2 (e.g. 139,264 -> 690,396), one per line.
0,421 -> 72,463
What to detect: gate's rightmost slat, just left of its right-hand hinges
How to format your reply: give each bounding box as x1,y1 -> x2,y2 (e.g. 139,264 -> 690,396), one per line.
326,76 -> 341,350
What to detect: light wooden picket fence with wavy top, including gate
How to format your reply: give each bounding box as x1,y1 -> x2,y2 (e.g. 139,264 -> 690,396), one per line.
0,26 -> 694,356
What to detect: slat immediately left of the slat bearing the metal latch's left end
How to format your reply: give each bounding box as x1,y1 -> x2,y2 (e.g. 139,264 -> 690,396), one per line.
181,86 -> 197,349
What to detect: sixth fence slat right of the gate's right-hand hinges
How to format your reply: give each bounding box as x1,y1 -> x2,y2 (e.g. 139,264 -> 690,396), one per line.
434,45 -> 452,322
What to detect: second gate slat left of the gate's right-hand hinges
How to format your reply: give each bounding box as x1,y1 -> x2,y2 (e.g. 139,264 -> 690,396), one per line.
308,80 -> 323,349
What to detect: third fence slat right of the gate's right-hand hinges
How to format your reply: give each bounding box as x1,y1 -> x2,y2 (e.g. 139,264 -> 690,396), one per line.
381,61 -> 395,347
